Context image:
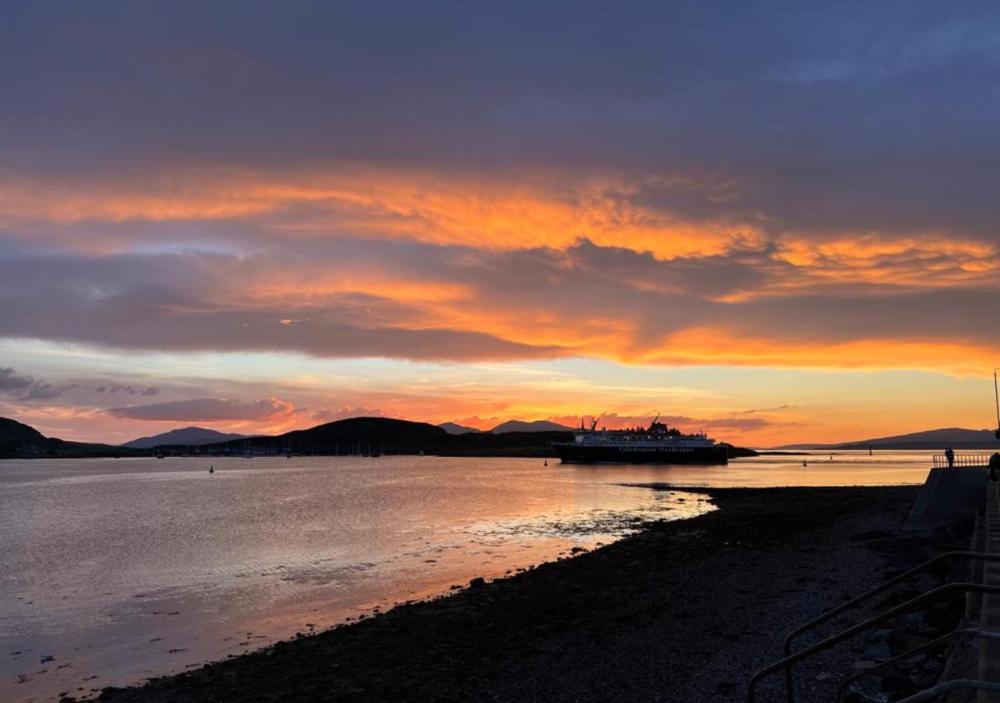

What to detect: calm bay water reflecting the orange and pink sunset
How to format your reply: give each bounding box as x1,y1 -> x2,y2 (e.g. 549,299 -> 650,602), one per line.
0,452 -> 930,701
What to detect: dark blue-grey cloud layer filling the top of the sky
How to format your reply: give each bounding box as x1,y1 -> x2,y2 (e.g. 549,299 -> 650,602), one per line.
0,2 -> 1000,236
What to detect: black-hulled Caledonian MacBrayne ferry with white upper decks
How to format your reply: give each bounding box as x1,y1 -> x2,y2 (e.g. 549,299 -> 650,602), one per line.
552,415 -> 729,464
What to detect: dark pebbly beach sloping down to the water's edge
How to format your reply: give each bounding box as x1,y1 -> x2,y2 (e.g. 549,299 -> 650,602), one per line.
94,486 -> 967,702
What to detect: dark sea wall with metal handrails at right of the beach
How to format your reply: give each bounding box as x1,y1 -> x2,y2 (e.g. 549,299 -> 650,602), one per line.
746,454 -> 1000,703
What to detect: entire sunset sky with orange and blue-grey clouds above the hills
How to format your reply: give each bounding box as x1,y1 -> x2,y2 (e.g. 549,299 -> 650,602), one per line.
0,0 -> 1000,446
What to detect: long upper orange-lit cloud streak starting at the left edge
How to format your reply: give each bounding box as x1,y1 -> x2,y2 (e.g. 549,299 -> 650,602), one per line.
0,170 -> 763,258
